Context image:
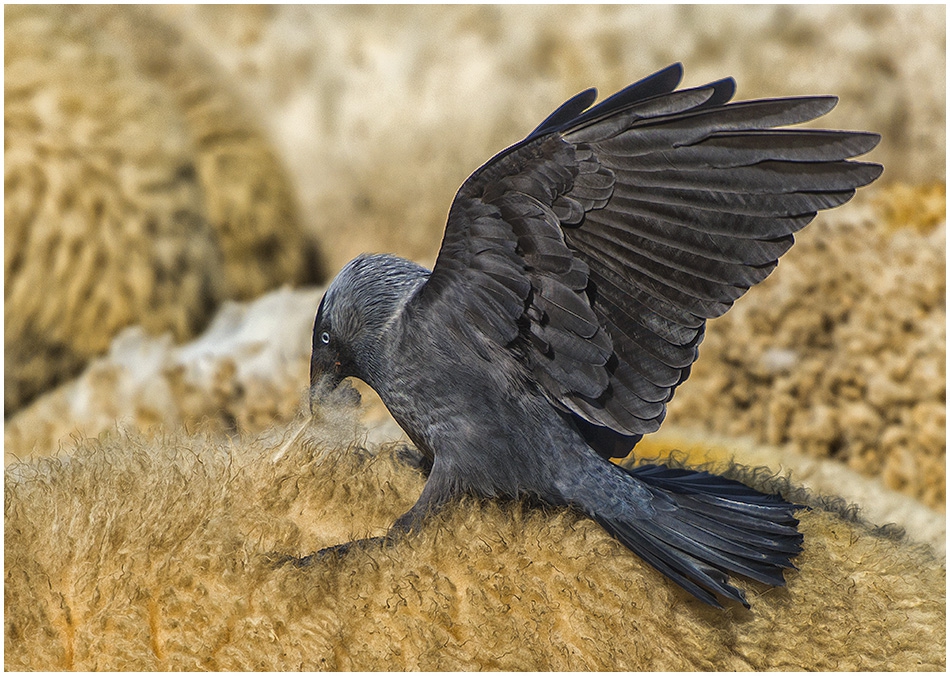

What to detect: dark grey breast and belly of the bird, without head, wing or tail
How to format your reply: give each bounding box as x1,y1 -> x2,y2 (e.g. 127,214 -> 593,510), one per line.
346,262 -> 593,504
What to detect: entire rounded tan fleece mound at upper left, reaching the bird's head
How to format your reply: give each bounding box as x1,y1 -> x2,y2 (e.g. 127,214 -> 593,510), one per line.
4,5 -> 312,414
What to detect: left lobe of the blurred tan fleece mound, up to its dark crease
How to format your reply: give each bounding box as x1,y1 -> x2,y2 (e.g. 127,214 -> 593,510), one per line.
4,6 -> 221,413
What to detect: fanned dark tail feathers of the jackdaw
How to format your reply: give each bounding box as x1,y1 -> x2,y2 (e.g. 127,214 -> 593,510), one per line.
572,465 -> 803,608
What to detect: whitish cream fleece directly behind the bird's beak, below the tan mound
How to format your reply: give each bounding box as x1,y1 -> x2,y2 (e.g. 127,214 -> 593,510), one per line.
3,288 -> 402,462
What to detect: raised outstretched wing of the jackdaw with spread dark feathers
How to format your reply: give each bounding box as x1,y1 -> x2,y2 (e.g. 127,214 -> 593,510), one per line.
414,64 -> 882,456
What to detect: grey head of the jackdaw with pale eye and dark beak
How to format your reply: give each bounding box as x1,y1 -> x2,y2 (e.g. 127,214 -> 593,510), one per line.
310,254 -> 429,409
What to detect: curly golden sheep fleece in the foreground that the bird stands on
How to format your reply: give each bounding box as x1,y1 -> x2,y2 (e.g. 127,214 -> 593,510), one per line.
4,418 -> 945,671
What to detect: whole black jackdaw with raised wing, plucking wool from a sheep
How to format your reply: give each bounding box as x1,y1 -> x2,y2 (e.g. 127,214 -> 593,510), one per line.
306,64 -> 882,607
